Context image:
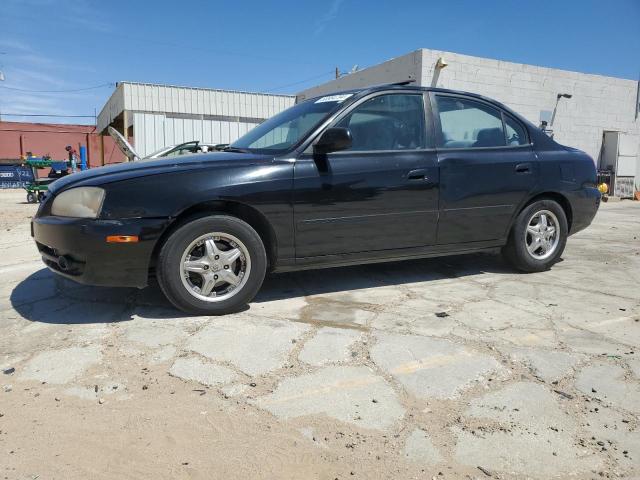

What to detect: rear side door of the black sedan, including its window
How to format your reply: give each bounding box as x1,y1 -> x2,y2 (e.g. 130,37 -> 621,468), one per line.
431,93 -> 538,244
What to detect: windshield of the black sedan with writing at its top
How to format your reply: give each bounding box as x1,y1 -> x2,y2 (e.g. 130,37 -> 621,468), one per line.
227,94 -> 352,153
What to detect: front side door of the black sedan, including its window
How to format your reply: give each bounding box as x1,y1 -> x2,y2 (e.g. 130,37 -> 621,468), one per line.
294,91 -> 438,258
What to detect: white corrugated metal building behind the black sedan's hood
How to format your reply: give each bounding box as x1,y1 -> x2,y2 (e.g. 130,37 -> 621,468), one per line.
97,82 -> 295,156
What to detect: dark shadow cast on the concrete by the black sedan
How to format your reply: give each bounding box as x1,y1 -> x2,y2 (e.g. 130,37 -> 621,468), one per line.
10,254 -> 513,325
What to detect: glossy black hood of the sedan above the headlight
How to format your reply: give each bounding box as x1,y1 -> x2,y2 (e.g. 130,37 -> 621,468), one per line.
48,152 -> 273,195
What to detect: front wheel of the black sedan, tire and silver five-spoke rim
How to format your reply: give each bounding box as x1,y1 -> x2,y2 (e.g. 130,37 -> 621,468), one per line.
156,215 -> 267,315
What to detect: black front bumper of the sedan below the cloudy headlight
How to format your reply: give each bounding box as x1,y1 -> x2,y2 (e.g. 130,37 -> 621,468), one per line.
31,216 -> 169,288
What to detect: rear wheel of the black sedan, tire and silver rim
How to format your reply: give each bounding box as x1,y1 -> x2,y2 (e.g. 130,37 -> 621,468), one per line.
502,199 -> 568,272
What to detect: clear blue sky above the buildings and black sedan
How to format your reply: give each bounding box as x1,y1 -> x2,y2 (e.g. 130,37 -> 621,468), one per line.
0,0 -> 640,123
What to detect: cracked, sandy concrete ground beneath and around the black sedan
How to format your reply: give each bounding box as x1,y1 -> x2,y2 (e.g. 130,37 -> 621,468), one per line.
0,191 -> 640,479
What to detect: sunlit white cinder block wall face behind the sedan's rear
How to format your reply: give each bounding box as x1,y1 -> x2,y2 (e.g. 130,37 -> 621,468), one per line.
420,49 -> 640,182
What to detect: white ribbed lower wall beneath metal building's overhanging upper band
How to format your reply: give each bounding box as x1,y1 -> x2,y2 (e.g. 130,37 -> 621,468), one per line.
133,113 -> 257,156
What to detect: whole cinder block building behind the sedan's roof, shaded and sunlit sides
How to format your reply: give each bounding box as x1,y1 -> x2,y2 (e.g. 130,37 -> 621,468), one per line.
297,49 -> 640,197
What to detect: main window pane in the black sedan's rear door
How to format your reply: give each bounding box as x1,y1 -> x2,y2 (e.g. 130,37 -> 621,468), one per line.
436,95 -> 506,148
